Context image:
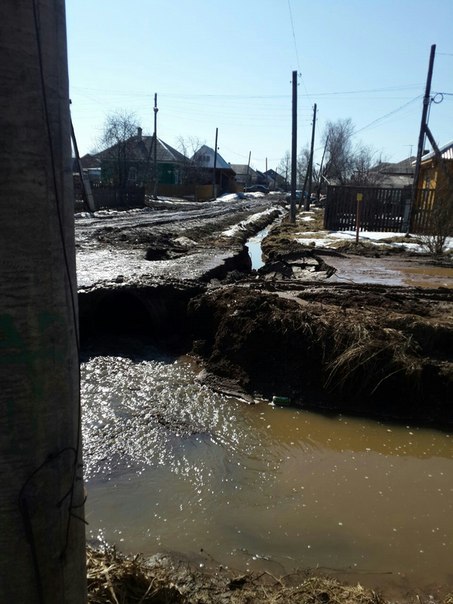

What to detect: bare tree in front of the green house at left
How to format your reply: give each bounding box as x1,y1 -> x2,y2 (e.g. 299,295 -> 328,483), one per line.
99,110 -> 137,188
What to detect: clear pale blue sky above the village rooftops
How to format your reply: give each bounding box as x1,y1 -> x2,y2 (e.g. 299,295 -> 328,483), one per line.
66,0 -> 453,170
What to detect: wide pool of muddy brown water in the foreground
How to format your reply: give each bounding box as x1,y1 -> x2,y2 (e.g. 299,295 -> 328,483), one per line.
82,348 -> 453,593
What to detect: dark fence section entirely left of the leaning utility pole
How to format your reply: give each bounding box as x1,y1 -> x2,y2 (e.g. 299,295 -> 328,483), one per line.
324,186 -> 411,233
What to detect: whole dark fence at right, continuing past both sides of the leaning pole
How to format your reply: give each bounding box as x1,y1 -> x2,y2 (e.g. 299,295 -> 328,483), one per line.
324,186 -> 434,233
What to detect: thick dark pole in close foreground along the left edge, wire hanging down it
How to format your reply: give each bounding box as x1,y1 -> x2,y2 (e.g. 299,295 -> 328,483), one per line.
0,0 -> 86,604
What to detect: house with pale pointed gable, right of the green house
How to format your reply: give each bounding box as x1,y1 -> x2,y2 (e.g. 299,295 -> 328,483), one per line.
191,145 -> 236,195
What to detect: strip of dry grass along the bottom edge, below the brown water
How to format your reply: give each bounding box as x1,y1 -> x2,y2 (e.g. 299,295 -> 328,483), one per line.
87,548 -> 388,604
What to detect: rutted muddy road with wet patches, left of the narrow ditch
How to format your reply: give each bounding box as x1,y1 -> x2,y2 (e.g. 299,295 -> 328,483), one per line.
76,193 -> 283,291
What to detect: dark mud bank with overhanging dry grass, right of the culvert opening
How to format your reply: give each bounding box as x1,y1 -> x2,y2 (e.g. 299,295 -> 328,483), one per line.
188,281 -> 453,424
